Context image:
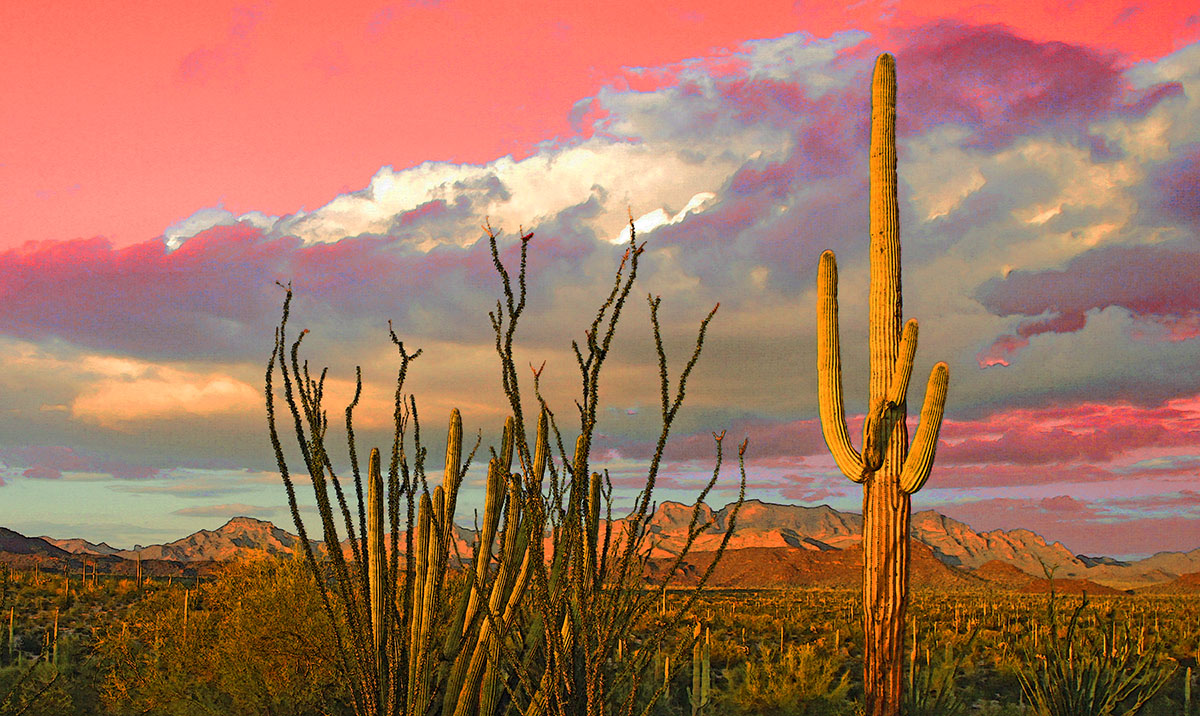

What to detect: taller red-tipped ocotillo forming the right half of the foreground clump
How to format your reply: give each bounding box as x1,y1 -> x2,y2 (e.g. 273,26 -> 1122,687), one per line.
488,225 -> 746,716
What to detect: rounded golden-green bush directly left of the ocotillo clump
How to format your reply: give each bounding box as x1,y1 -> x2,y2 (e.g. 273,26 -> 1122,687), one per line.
95,551 -> 346,716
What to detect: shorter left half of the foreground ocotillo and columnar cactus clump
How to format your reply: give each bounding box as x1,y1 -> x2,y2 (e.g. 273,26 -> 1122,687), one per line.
266,290 -> 546,716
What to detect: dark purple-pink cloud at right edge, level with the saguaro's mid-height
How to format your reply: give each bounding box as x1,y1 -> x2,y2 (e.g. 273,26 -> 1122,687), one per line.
977,243 -> 1200,366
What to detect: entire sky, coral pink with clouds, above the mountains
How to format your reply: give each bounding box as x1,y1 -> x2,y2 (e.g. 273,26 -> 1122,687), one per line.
0,0 -> 1200,556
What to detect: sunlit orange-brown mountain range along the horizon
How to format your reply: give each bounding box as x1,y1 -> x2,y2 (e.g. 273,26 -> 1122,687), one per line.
0,500 -> 1200,594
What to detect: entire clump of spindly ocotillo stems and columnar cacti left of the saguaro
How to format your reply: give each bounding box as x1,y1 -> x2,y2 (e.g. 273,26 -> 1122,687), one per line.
265,221 -> 745,716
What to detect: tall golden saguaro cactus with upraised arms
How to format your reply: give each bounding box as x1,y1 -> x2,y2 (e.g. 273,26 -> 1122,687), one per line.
817,54 -> 949,716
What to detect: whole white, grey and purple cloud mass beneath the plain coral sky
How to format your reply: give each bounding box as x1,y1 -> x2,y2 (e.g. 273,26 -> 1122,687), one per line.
0,23 -> 1200,551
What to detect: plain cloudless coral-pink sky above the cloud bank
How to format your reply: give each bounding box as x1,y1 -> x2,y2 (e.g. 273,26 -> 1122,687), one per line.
0,0 -> 1200,246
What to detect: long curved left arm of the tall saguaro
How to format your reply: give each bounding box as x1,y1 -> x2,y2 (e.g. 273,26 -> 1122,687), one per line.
817,251 -> 865,482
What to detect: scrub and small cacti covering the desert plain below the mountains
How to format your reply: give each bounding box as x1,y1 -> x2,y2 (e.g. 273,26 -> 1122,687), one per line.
0,553 -> 1200,716
